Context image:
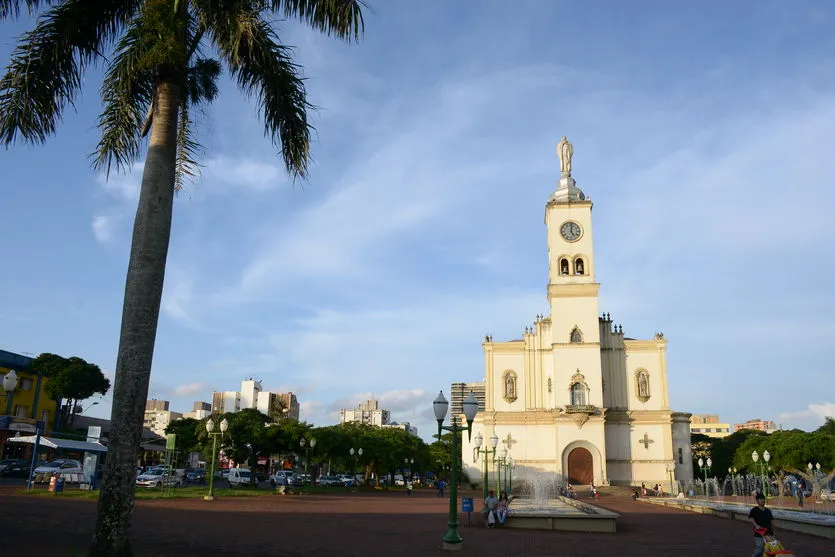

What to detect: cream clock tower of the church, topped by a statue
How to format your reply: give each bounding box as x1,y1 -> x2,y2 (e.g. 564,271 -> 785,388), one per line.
545,137 -> 603,408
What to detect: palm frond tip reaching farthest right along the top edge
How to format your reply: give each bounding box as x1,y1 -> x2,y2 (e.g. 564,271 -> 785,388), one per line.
267,0 -> 367,41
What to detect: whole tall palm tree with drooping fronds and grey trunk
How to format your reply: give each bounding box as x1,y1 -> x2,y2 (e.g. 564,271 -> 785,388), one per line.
0,0 -> 365,556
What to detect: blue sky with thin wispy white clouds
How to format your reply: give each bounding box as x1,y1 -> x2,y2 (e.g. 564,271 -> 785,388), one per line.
0,0 -> 835,439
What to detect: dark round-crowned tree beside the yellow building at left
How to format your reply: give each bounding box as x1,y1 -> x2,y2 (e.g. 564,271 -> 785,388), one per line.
31,352 -> 110,423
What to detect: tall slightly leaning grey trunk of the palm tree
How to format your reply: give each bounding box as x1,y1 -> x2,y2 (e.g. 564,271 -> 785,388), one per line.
90,78 -> 180,557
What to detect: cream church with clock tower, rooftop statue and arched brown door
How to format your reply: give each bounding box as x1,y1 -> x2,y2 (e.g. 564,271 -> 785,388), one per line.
462,137 -> 693,490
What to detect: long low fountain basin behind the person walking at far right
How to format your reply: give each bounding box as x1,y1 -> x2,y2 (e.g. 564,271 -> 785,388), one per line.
637,497 -> 835,539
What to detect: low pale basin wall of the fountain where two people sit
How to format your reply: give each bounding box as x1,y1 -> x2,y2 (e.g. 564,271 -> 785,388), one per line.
505,497 -> 620,533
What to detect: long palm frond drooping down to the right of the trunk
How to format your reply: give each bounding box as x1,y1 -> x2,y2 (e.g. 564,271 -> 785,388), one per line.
208,10 -> 315,178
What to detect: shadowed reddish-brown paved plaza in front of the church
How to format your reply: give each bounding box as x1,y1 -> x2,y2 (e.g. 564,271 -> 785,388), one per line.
0,488 -> 835,557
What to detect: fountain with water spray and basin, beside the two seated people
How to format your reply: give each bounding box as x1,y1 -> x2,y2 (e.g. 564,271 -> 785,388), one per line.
505,471 -> 618,532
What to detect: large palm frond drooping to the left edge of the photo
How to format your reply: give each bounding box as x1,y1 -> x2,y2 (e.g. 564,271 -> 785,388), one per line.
0,0 -> 143,145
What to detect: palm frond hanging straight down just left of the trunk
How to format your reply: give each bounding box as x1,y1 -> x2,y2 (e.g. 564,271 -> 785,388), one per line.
93,25 -> 154,175
